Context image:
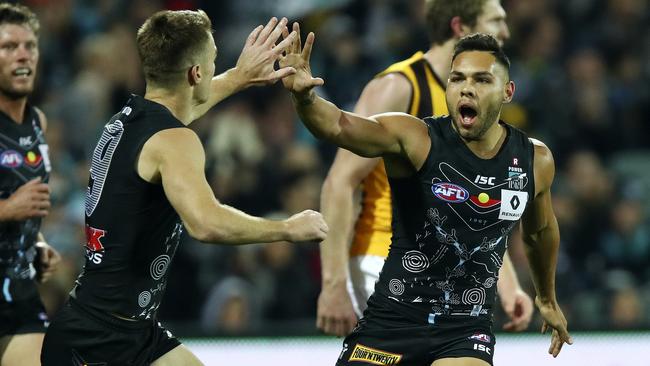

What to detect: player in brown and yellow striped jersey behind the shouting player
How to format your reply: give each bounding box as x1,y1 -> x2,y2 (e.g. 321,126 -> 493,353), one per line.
317,0 -> 533,336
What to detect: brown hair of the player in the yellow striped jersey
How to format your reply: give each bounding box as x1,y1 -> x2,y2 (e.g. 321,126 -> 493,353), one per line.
426,0 -> 486,44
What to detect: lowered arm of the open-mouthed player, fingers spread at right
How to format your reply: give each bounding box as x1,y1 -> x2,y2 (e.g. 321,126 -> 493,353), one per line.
521,140 -> 573,357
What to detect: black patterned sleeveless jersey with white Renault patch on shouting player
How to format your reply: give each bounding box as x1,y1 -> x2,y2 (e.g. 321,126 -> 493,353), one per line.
372,116 -> 535,323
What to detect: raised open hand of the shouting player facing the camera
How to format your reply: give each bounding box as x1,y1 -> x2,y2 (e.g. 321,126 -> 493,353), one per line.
279,23 -> 325,95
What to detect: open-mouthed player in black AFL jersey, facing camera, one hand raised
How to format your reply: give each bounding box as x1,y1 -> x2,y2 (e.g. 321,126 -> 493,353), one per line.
280,29 -> 572,366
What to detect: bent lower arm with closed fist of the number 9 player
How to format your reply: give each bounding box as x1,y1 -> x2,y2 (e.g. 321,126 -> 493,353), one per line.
137,128 -> 327,244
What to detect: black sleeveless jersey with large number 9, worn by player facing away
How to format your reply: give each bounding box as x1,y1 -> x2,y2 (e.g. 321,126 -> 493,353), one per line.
71,95 -> 185,320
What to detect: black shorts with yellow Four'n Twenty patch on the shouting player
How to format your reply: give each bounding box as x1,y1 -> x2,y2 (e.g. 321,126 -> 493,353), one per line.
336,307 -> 496,366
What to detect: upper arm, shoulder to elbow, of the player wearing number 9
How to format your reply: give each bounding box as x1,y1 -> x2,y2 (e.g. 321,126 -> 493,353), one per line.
149,129 -> 217,237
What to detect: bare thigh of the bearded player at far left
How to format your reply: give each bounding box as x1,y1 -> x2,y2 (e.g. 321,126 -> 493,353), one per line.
0,333 -> 45,366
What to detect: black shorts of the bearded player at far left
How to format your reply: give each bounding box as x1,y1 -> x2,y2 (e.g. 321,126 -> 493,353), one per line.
0,296 -> 48,337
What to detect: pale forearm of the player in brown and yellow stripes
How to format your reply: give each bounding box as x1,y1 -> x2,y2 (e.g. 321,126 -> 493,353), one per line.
320,179 -> 354,286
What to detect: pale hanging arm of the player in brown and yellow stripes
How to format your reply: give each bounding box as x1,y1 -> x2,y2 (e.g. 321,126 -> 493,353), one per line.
316,74 -> 410,337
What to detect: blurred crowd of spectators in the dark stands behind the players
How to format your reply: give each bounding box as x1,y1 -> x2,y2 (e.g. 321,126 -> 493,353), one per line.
24,0 -> 650,335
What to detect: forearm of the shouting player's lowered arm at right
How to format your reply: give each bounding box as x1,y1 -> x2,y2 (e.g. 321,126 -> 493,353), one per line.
523,217 -> 560,302
